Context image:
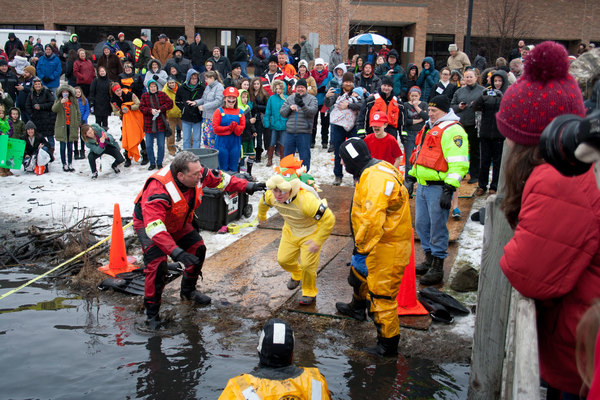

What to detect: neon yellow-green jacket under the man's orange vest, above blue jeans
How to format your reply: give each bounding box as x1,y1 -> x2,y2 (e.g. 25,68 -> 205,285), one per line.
408,109 -> 469,188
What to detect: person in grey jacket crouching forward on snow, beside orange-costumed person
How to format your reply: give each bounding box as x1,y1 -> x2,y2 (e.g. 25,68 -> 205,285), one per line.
81,124 -> 125,179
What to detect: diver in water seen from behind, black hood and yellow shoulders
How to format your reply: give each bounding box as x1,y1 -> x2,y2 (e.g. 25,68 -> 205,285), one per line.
219,318 -> 331,400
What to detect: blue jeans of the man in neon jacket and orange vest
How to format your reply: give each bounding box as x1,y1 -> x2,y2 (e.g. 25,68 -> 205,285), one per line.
415,184 -> 450,258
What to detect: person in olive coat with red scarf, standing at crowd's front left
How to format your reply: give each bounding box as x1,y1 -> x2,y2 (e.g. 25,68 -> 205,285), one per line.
52,85 -> 81,172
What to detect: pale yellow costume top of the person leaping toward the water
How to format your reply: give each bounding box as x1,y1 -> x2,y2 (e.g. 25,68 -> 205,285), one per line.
258,188 -> 335,245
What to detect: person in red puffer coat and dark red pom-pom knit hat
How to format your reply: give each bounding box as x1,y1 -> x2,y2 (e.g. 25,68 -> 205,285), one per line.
496,42 -> 600,399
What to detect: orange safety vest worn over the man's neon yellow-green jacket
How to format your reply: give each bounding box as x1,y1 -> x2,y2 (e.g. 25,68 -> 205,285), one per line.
410,121 -> 458,172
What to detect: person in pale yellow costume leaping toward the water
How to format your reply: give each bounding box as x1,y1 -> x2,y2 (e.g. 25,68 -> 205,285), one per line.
258,154 -> 335,305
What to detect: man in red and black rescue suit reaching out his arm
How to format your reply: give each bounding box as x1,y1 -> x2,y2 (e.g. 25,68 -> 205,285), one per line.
133,151 -> 266,329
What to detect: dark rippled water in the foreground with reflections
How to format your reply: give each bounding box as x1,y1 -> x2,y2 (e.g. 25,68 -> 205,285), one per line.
0,269 -> 468,399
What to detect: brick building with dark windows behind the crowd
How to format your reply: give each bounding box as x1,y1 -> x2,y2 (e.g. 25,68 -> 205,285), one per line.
0,0 -> 600,64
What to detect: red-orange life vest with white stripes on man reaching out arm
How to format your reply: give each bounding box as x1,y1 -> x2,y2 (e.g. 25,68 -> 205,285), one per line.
134,166 -> 202,232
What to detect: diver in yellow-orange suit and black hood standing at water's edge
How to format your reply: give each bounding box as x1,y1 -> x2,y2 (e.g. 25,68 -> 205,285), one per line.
335,138 -> 412,356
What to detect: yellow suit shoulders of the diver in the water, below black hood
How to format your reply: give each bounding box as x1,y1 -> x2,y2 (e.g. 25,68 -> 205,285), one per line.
219,368 -> 331,400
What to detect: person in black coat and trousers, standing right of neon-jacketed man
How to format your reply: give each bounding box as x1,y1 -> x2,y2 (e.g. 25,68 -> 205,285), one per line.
473,70 -> 508,196
